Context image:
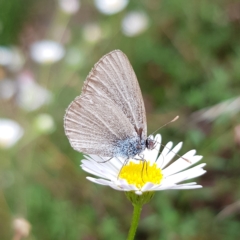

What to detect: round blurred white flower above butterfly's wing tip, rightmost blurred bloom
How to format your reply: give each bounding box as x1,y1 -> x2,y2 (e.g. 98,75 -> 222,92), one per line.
122,11 -> 149,37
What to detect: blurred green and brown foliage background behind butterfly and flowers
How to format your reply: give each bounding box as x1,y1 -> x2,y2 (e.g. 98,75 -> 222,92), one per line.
0,0 -> 240,240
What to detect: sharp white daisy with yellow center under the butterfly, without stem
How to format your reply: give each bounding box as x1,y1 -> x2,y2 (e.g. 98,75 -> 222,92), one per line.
81,134 -> 206,195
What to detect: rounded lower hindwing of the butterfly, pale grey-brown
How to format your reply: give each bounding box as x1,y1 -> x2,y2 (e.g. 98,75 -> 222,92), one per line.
64,94 -> 139,157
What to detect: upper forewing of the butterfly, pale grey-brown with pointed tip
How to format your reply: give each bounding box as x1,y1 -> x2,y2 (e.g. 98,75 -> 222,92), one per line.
82,50 -> 147,138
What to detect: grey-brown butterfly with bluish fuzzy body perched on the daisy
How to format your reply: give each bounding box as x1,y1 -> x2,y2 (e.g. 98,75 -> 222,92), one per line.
64,50 -> 154,159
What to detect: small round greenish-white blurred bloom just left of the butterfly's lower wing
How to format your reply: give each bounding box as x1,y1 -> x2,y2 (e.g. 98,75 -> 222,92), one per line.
34,113 -> 55,133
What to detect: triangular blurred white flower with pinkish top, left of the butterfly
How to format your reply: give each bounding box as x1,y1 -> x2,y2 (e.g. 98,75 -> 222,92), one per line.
16,72 -> 52,111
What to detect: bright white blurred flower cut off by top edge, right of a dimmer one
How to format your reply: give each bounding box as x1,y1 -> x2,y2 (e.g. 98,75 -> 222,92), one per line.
95,0 -> 129,15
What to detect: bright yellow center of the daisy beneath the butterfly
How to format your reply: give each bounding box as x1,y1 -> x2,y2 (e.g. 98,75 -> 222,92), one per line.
119,161 -> 163,189
